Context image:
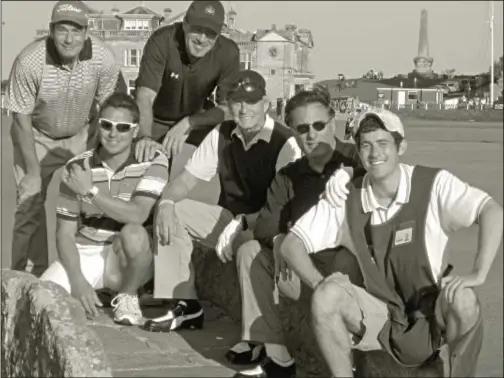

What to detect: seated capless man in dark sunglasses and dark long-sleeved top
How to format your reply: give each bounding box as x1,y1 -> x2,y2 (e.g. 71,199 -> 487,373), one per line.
230,88 -> 365,378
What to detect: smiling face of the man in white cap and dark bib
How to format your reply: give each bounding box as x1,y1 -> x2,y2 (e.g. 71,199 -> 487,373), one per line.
358,128 -> 406,181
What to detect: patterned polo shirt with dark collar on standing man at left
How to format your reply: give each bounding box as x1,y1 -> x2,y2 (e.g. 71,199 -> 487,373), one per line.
6,37 -> 120,139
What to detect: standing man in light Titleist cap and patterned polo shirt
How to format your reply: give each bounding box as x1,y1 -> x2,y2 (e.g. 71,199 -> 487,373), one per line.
6,1 -> 123,276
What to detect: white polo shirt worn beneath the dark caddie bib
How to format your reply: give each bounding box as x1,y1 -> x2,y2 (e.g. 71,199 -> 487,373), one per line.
291,164 -> 491,280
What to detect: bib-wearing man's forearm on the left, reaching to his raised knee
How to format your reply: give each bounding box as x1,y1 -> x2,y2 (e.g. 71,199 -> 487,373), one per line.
280,234 -> 324,289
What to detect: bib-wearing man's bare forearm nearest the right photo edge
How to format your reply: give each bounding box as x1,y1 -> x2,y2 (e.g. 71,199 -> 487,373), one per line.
473,199 -> 503,283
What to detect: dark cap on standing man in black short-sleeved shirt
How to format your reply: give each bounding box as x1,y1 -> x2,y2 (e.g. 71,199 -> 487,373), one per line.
185,0 -> 224,34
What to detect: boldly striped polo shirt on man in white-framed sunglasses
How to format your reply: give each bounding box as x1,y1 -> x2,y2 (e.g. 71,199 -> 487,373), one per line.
56,147 -> 168,245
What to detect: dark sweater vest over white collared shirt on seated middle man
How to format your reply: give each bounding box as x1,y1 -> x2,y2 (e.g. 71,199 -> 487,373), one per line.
218,121 -> 292,215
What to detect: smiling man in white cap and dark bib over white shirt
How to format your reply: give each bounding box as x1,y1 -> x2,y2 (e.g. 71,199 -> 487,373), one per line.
281,110 -> 503,377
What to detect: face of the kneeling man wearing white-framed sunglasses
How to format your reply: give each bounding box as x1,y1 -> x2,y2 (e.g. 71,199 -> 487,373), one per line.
99,107 -> 138,157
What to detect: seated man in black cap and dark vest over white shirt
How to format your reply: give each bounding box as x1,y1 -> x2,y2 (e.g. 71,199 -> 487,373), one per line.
140,70 -> 301,332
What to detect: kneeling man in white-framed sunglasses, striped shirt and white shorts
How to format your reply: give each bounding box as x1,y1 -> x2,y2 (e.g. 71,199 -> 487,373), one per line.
41,93 -> 168,325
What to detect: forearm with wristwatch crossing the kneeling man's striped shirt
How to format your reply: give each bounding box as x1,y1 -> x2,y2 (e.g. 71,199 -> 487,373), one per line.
93,191 -> 149,224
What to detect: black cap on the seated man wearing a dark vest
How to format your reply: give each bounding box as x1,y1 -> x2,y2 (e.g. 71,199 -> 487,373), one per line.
227,70 -> 266,102
